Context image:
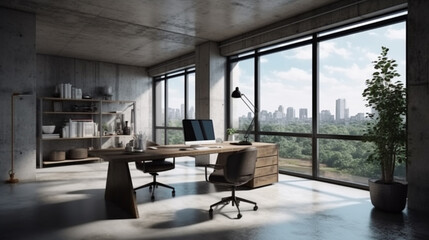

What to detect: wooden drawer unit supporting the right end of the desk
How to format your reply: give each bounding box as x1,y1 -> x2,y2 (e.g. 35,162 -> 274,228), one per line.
246,144 -> 279,188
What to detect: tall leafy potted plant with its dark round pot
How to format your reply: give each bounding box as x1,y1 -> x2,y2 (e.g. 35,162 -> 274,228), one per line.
362,47 -> 407,212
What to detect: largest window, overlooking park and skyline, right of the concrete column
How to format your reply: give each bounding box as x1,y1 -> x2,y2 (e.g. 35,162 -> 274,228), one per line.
228,13 -> 406,186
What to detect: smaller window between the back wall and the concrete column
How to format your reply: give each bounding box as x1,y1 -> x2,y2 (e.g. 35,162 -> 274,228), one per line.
153,68 -> 195,144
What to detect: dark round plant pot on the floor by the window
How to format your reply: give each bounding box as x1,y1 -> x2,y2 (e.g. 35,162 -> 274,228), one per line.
368,179 -> 408,212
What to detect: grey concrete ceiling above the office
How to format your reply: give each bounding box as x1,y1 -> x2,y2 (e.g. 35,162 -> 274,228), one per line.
0,0 -> 338,67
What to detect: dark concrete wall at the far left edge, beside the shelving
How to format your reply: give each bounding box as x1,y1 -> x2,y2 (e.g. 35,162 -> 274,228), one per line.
0,8 -> 36,181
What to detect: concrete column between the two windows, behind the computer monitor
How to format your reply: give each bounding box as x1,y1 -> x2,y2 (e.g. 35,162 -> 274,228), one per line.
195,42 -> 226,165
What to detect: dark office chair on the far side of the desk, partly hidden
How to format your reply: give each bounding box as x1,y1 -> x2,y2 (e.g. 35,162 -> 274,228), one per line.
134,141 -> 176,201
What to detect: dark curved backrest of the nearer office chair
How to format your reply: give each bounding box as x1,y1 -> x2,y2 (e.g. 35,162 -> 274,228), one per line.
224,147 -> 257,186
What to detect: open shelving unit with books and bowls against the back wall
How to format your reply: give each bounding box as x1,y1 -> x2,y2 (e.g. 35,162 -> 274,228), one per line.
37,97 -> 136,168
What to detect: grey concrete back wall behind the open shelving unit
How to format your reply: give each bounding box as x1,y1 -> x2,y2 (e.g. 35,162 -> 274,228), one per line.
36,55 -> 152,162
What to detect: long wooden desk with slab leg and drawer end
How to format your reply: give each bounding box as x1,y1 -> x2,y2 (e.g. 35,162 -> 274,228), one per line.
95,143 -> 278,218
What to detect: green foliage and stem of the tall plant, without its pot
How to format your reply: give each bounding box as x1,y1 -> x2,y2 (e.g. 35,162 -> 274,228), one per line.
362,47 -> 407,183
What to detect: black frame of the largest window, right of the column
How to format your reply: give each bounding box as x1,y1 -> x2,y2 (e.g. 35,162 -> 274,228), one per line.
226,10 -> 408,189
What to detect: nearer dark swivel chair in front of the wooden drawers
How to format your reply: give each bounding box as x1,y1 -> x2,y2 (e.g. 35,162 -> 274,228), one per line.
205,147 -> 258,219
